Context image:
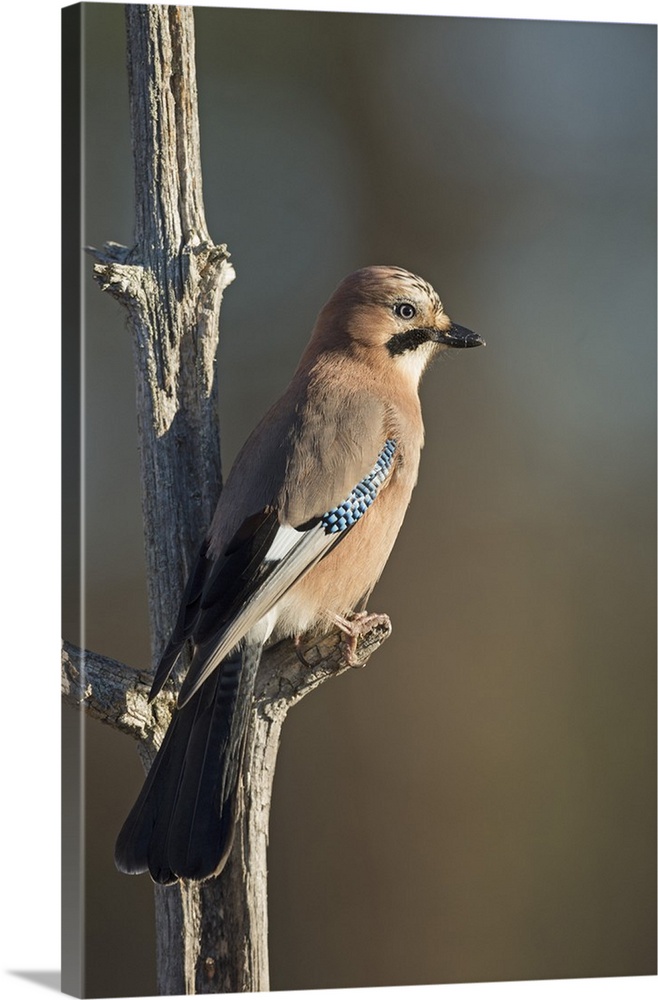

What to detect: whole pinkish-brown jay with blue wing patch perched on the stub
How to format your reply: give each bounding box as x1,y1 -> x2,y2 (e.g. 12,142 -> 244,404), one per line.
115,267 -> 483,883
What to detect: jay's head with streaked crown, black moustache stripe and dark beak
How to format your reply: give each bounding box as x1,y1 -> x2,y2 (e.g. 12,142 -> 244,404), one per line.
311,267 -> 484,383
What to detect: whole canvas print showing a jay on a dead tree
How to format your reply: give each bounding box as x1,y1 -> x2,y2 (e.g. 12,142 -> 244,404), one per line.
62,3 -> 656,997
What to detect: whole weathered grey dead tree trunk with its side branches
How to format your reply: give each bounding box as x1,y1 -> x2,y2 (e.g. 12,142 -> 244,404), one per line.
62,5 -> 390,995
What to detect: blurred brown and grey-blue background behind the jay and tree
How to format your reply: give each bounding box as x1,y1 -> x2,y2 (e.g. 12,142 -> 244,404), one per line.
65,4 -> 656,996
